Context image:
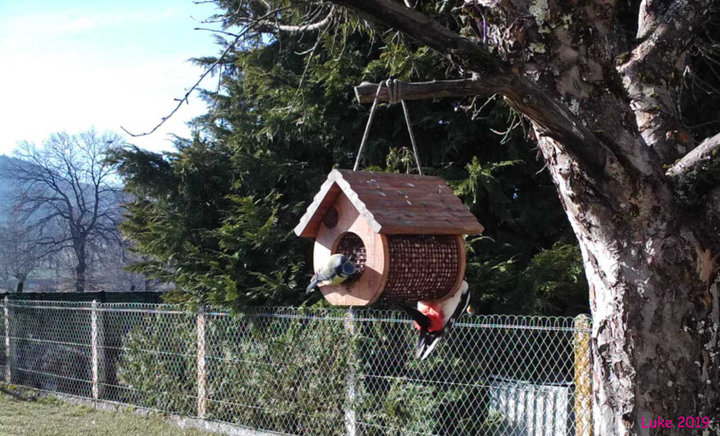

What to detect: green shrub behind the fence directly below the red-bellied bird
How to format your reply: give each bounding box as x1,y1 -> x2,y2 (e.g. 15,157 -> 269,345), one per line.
357,311 -> 496,436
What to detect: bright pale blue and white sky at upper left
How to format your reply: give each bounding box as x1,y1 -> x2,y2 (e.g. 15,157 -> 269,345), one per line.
0,0 -> 220,155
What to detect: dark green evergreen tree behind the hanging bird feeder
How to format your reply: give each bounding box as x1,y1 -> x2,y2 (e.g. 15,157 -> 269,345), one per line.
115,1 -> 587,314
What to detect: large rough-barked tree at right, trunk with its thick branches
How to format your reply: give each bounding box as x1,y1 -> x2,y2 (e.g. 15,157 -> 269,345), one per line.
333,0 -> 720,435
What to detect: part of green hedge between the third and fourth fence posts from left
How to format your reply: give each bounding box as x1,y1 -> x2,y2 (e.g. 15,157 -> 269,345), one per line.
202,310 -> 352,435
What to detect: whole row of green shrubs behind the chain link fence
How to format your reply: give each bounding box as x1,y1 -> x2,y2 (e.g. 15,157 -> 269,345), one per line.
118,309 -> 498,436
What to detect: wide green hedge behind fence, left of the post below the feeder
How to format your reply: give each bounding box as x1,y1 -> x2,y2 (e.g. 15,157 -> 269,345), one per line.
118,308 -> 352,435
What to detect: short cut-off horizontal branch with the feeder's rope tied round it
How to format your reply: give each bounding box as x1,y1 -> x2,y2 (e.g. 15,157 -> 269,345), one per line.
355,79 -> 499,104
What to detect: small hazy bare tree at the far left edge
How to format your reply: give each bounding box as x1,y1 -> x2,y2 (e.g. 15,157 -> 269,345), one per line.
0,216 -> 44,292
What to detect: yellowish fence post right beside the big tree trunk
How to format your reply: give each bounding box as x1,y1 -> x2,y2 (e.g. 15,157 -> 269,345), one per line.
573,315 -> 593,436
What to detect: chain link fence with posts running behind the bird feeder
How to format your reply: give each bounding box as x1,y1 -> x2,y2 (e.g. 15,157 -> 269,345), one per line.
0,300 -> 592,436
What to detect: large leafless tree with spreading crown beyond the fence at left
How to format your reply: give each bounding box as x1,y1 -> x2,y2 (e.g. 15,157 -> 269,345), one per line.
11,130 -> 123,292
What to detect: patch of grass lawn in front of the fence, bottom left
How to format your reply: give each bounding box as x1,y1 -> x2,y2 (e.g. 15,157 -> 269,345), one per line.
0,386 -> 211,436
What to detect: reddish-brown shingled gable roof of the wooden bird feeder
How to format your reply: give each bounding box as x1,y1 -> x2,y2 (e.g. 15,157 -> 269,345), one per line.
295,170 -> 483,238
